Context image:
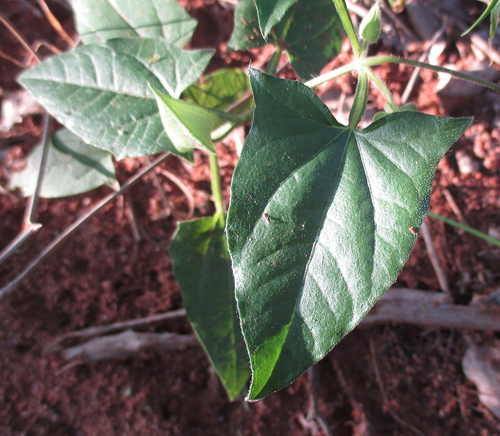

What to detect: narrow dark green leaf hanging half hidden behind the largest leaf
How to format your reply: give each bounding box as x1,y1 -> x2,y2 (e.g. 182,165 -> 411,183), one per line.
170,214 -> 250,399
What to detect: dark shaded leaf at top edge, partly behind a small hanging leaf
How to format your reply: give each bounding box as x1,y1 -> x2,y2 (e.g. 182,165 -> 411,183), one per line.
229,0 -> 343,80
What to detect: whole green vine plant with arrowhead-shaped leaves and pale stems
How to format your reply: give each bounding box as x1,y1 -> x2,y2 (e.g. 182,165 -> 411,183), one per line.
3,0 -> 500,401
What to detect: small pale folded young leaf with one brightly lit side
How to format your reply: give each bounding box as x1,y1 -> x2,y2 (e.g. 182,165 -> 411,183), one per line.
151,86 -> 221,153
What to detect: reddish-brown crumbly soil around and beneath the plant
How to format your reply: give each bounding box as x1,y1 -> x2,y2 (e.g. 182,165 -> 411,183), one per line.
0,0 -> 500,436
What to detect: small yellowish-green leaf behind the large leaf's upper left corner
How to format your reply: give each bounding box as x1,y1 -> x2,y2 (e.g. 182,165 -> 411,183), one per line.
183,68 -> 253,113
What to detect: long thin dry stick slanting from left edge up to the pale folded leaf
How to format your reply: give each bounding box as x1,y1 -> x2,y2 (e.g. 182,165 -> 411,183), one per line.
0,152 -> 170,300
